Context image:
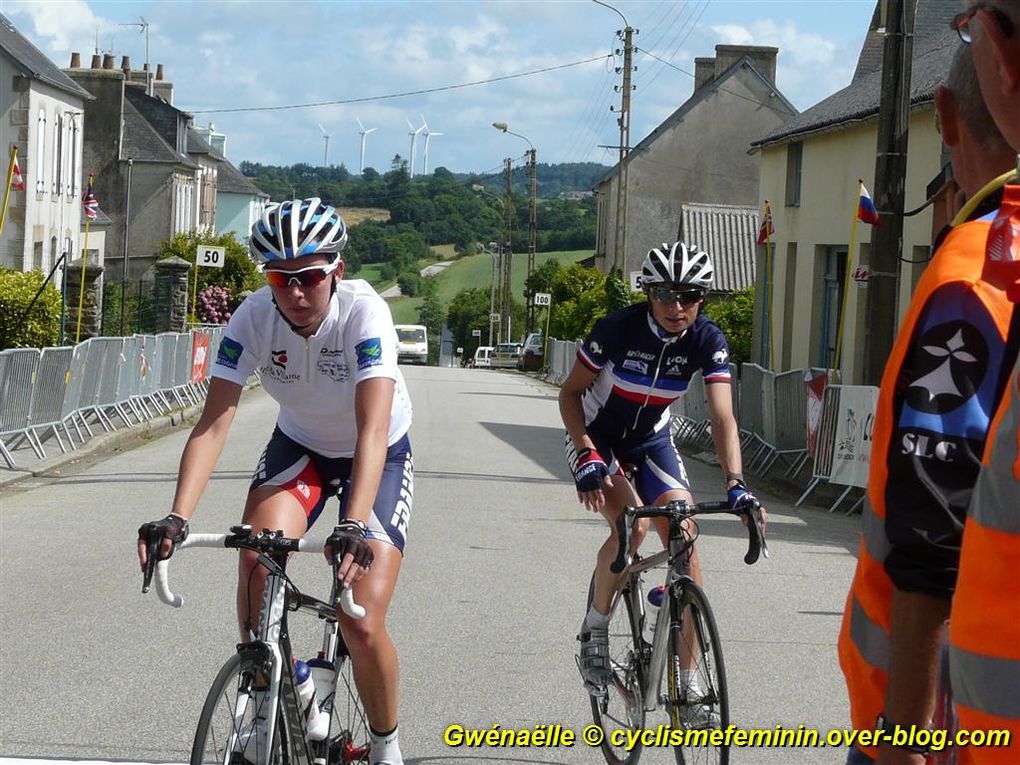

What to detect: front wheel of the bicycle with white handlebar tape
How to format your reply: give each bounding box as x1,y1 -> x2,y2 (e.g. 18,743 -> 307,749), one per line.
191,654 -> 284,765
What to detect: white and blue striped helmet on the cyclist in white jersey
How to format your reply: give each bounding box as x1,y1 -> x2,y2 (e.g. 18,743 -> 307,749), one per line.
249,197 -> 347,263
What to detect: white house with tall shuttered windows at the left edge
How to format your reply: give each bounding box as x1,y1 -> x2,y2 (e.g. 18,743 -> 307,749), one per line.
0,15 -> 92,273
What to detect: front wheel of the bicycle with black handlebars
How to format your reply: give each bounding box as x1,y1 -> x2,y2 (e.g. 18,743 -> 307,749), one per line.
664,581 -> 729,765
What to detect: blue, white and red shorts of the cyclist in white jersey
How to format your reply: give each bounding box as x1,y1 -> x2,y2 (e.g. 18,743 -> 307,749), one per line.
248,427 -> 414,553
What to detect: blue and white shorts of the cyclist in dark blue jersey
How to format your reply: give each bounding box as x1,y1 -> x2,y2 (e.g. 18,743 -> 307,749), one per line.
564,427 -> 691,503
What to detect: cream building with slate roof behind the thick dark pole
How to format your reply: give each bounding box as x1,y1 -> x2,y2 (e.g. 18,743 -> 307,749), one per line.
753,0 -> 961,383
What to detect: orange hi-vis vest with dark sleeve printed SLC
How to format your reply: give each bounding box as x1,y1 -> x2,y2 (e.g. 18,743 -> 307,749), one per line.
838,213 -> 1013,757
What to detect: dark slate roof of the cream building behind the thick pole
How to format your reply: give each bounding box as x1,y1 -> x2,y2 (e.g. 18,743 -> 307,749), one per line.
751,0 -> 962,149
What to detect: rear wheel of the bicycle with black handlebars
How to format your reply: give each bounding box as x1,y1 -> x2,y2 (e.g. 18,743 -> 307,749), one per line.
584,574 -> 645,765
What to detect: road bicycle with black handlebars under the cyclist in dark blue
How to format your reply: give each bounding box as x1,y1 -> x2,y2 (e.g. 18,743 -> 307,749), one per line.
588,500 -> 768,765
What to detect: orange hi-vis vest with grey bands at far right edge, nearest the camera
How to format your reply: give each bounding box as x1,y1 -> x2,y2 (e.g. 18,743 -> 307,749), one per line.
950,187 -> 1020,765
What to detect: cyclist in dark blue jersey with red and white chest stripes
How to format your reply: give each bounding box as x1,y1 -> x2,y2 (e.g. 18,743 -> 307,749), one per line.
559,242 -> 755,689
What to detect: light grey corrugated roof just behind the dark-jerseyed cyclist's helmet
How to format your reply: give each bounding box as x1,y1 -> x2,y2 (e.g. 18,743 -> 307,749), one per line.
679,202 -> 758,292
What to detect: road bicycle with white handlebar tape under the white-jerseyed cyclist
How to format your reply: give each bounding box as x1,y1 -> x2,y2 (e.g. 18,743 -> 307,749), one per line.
142,524 -> 369,765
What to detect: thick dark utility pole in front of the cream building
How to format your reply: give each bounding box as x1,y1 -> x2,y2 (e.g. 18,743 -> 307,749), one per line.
864,0 -> 916,386
